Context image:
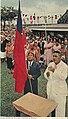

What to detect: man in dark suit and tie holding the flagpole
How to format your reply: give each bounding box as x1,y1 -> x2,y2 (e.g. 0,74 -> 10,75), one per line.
24,52 -> 41,94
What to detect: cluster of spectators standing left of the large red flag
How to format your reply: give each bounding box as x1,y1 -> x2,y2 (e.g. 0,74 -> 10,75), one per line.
0,30 -> 15,73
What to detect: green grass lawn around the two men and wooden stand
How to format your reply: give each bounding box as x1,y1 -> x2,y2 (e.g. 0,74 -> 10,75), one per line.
1,63 -> 68,117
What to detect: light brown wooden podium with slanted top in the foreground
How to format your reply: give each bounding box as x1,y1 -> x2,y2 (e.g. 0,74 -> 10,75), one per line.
13,92 -> 57,117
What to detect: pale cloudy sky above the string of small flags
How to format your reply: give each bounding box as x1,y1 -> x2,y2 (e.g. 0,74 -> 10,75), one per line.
1,0 -> 68,16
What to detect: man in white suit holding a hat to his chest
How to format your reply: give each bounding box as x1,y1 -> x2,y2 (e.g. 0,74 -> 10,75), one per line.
44,51 -> 68,117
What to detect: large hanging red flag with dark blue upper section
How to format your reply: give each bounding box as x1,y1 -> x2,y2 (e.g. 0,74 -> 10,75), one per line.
13,0 -> 27,93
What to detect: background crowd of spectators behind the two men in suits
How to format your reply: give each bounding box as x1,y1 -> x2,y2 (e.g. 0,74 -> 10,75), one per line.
1,26 -> 68,69
